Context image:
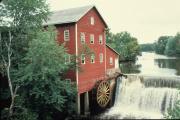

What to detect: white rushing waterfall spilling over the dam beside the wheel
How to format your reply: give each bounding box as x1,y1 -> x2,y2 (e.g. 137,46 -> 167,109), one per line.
101,75 -> 180,119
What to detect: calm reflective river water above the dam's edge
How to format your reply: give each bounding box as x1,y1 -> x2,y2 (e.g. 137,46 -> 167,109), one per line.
120,52 -> 180,76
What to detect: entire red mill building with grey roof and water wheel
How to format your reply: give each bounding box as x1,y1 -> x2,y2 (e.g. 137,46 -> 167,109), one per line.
44,6 -> 120,114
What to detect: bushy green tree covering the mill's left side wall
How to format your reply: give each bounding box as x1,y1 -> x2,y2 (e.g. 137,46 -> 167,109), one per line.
16,28 -> 76,119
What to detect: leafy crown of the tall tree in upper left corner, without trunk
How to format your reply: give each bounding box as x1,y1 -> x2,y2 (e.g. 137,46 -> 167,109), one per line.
0,0 -> 50,63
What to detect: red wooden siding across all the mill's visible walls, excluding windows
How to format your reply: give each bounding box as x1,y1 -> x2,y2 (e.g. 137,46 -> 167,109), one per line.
52,7 -> 118,94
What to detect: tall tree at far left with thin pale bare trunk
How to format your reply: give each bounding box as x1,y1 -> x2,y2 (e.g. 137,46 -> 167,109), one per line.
0,0 -> 49,117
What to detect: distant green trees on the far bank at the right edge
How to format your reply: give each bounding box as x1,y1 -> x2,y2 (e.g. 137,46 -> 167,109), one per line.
141,33 -> 180,56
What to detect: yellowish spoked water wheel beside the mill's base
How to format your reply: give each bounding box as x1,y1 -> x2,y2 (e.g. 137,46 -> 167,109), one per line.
96,81 -> 110,107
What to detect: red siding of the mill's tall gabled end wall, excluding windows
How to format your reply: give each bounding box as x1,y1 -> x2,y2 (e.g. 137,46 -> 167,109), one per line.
77,9 -> 106,93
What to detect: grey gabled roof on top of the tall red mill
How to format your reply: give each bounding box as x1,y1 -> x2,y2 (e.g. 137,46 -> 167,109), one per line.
43,5 -> 107,27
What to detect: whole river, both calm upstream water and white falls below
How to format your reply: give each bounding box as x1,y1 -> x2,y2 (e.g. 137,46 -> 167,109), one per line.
100,52 -> 180,119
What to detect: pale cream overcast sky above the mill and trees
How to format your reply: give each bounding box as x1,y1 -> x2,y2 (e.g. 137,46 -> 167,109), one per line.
47,0 -> 180,44
